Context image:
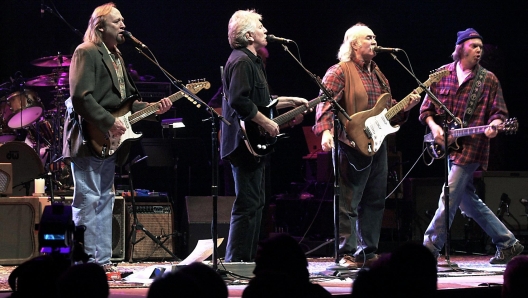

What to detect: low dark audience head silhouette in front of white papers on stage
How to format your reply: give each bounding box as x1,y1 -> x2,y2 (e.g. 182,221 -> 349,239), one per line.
147,262 -> 228,298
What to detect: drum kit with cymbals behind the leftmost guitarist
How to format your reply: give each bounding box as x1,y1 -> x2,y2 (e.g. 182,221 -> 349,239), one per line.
0,53 -> 73,195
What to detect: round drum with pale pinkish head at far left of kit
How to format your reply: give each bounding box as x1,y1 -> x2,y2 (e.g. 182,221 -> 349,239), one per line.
7,89 -> 44,128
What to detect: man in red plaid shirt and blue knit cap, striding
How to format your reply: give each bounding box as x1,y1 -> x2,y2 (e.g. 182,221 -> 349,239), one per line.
419,28 -> 524,264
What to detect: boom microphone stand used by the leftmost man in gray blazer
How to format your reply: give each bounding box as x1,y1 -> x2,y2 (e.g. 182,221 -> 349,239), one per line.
131,47 -> 231,271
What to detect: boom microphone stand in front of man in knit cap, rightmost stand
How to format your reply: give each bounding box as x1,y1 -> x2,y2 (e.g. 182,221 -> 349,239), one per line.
391,53 -> 461,267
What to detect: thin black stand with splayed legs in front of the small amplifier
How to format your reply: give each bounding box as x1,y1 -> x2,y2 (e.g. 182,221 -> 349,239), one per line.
125,155 -> 181,262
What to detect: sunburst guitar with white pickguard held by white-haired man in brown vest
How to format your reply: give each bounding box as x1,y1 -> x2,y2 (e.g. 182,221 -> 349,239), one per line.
345,69 -> 449,156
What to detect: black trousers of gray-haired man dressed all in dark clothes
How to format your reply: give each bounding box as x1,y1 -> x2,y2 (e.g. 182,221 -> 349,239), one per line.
225,155 -> 266,262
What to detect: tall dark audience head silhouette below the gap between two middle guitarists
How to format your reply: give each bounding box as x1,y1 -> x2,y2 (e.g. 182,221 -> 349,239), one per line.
242,234 -> 331,298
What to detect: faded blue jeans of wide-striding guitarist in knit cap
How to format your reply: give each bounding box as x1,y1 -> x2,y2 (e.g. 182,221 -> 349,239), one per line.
423,161 -> 516,257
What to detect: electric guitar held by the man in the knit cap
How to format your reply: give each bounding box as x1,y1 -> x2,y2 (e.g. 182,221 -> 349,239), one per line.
424,117 -> 519,159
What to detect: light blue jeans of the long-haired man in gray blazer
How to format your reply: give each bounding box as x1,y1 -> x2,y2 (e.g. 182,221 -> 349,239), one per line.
72,155 -> 115,265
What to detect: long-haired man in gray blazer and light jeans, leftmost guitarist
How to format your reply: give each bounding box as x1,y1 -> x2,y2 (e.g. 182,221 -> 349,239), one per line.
63,3 -> 172,266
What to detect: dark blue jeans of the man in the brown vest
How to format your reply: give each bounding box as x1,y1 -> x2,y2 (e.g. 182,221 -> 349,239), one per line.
339,141 -> 388,260
